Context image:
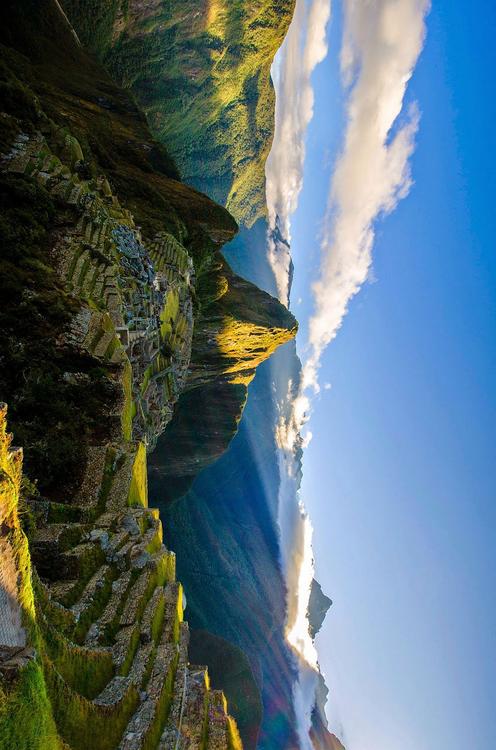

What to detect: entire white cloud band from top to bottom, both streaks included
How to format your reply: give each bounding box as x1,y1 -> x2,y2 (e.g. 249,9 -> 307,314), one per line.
266,0 -> 430,750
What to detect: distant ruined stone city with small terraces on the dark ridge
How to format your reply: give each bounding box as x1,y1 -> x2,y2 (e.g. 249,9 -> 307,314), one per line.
2,132 -> 195,448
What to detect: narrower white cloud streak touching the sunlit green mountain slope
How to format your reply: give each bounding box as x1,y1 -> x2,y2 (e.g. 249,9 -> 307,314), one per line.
265,0 -> 331,305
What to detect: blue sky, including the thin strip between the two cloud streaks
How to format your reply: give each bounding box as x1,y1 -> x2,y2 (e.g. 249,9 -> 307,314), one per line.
292,1 -> 496,750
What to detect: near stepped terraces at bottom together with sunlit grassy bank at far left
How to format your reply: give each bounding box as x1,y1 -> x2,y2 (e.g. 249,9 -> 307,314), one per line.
0,405 -> 240,750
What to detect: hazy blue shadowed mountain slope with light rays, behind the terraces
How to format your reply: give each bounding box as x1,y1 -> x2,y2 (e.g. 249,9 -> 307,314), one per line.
150,352 -> 298,750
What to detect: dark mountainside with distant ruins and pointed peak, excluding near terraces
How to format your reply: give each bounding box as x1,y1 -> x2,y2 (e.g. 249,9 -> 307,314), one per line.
0,0 -> 296,494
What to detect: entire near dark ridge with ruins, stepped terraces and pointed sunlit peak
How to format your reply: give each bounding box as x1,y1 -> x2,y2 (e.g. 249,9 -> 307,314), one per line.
0,0 -> 295,750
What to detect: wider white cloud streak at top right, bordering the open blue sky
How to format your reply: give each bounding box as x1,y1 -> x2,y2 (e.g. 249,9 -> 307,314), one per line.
300,0 -> 429,396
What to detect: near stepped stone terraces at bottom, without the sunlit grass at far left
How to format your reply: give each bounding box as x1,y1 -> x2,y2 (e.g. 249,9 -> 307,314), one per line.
0,409 -> 240,750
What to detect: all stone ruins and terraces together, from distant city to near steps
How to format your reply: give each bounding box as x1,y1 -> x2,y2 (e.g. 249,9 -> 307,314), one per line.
0,79 -> 240,750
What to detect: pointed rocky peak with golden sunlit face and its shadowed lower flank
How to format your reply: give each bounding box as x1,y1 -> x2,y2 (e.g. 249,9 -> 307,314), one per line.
150,261 -> 297,501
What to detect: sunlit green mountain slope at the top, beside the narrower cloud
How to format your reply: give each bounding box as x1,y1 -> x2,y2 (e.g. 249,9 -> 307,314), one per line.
63,0 -> 294,225
